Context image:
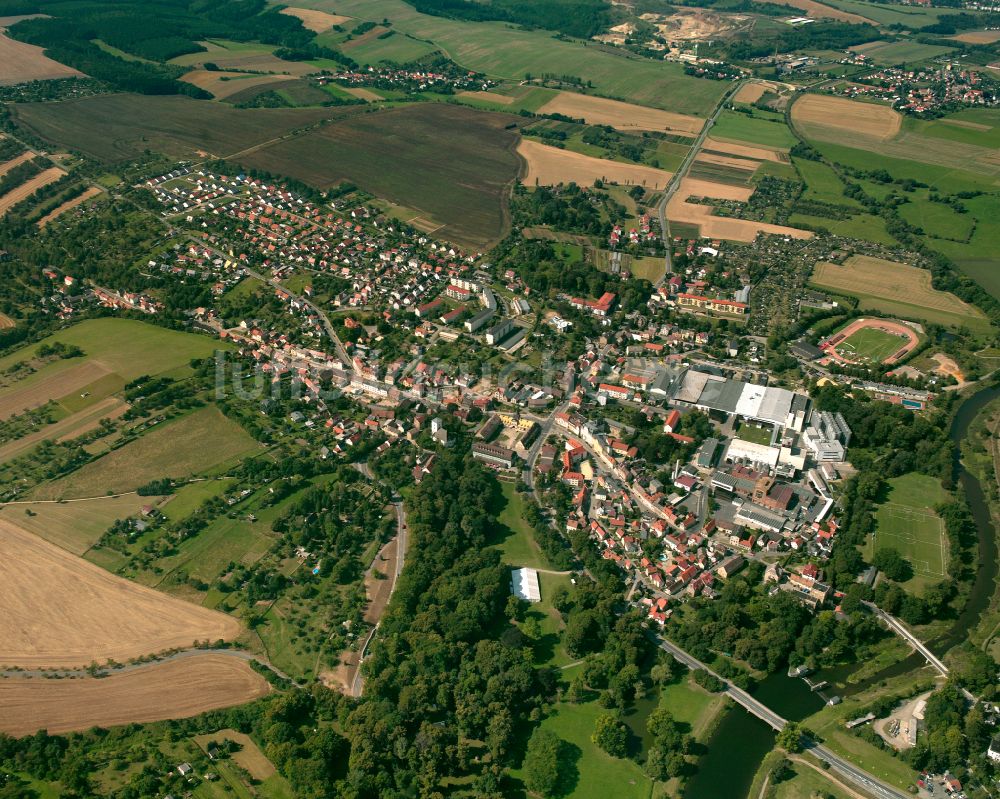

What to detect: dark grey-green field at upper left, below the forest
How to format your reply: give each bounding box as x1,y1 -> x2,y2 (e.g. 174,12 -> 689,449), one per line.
13,94 -> 358,163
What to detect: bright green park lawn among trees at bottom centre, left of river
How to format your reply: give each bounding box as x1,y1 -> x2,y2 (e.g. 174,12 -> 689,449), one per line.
511,701 -> 652,799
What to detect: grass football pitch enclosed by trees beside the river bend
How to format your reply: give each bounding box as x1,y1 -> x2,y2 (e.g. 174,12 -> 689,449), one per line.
866,473 -> 949,592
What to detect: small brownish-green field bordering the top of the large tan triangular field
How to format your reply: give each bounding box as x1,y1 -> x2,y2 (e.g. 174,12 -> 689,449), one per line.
0,494 -> 163,555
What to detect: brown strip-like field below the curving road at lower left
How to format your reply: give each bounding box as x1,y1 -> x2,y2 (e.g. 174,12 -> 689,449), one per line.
0,654 -> 271,736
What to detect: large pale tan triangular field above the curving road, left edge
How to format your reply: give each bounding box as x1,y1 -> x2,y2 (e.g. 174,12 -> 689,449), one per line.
0,520 -> 240,668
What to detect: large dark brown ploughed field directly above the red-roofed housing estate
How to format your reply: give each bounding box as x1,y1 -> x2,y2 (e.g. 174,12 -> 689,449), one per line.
239,103 -> 520,246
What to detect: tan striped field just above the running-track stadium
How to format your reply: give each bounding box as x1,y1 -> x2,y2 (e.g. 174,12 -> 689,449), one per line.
812,255 -> 983,317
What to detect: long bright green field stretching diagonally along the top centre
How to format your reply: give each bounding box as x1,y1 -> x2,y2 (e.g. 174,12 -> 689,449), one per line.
286,0 -> 726,116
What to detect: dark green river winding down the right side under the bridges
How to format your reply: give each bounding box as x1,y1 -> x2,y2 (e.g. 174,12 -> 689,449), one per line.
683,385 -> 1000,799
